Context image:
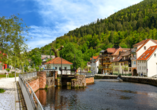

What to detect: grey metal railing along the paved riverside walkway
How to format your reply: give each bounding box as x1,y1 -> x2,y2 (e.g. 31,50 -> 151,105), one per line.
19,72 -> 44,110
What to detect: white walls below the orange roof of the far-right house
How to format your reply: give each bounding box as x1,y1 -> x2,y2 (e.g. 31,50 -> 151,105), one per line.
137,49 -> 157,77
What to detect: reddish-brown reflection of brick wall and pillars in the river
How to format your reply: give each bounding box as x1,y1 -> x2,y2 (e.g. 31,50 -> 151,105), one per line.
36,87 -> 85,110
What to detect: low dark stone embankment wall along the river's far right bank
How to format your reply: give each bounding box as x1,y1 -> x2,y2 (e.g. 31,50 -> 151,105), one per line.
95,74 -> 157,86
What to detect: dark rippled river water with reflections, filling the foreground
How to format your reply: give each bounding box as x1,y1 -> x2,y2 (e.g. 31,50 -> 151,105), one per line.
36,80 -> 157,110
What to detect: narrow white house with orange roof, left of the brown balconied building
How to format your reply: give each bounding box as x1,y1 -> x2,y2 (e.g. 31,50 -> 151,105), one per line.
90,56 -> 99,74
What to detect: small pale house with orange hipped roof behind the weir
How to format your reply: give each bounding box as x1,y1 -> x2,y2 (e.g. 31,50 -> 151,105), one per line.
45,57 -> 73,74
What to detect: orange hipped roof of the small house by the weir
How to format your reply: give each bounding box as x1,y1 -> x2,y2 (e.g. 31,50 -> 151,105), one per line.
45,57 -> 73,65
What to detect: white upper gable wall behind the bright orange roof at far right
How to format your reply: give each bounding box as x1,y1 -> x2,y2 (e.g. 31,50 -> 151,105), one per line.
136,40 -> 157,58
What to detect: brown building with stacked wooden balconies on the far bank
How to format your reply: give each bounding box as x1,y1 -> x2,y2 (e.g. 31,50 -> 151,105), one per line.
99,47 -> 125,74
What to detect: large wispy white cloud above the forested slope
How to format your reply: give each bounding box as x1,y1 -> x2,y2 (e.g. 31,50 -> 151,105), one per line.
26,0 -> 142,48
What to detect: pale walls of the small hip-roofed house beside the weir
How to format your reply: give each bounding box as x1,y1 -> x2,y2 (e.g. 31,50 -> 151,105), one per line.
50,64 -> 71,74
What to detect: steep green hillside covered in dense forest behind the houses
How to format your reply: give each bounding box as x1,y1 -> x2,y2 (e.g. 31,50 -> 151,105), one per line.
31,0 -> 157,67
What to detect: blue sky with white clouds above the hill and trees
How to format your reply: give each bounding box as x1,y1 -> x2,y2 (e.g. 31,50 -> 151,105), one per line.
0,0 -> 142,50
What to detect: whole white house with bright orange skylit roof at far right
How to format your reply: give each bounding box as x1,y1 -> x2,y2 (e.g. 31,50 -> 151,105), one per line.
137,45 -> 157,77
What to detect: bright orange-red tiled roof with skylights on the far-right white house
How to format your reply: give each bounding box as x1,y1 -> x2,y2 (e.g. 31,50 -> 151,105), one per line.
137,45 -> 157,60
